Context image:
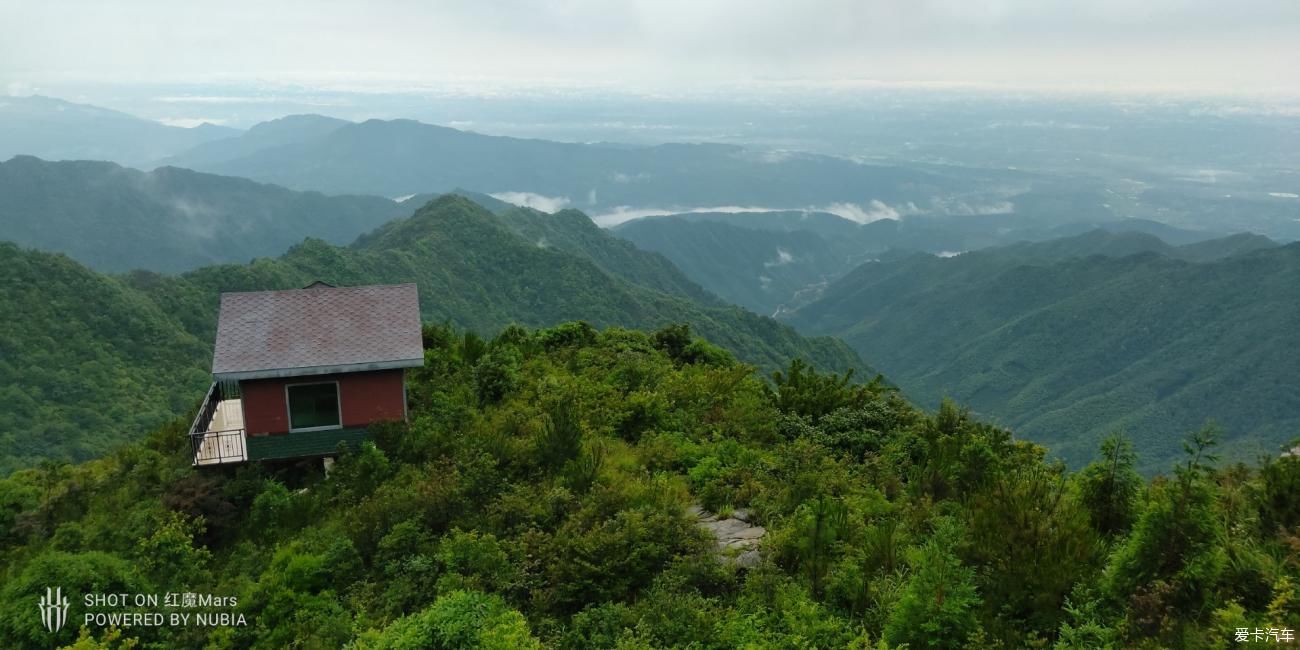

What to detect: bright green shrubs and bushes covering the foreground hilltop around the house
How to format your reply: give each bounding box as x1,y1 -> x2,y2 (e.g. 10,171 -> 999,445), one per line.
0,322 -> 1300,650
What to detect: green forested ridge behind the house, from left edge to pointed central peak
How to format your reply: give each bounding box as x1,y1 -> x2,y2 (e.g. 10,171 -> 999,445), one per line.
0,195 -> 870,472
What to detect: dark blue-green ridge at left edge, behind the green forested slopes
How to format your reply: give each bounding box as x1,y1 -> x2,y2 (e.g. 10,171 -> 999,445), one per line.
0,156 -> 412,272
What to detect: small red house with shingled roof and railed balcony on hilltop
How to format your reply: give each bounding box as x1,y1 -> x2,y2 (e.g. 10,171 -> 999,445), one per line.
190,282 -> 424,465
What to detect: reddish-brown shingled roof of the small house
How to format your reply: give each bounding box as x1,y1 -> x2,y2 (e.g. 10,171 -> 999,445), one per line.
212,283 -> 424,381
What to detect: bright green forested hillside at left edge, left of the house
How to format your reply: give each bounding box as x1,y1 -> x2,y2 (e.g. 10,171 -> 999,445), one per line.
0,242 -> 212,475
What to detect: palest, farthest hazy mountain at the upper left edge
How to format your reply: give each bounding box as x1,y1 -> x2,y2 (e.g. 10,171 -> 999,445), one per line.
0,95 -> 239,165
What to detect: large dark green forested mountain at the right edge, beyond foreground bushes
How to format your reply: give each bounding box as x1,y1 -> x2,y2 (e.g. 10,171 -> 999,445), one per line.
788,233 -> 1300,469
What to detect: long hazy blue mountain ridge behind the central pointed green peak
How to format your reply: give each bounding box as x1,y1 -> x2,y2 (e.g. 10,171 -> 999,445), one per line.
159,120 -> 980,209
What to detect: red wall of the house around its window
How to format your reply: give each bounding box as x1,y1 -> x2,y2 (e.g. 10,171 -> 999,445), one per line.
239,369 -> 406,436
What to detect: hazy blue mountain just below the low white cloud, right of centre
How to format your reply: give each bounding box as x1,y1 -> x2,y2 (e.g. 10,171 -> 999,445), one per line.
612,202 -> 1221,313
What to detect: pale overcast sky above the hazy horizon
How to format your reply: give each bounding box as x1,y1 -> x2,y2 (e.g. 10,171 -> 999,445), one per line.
0,0 -> 1300,95
